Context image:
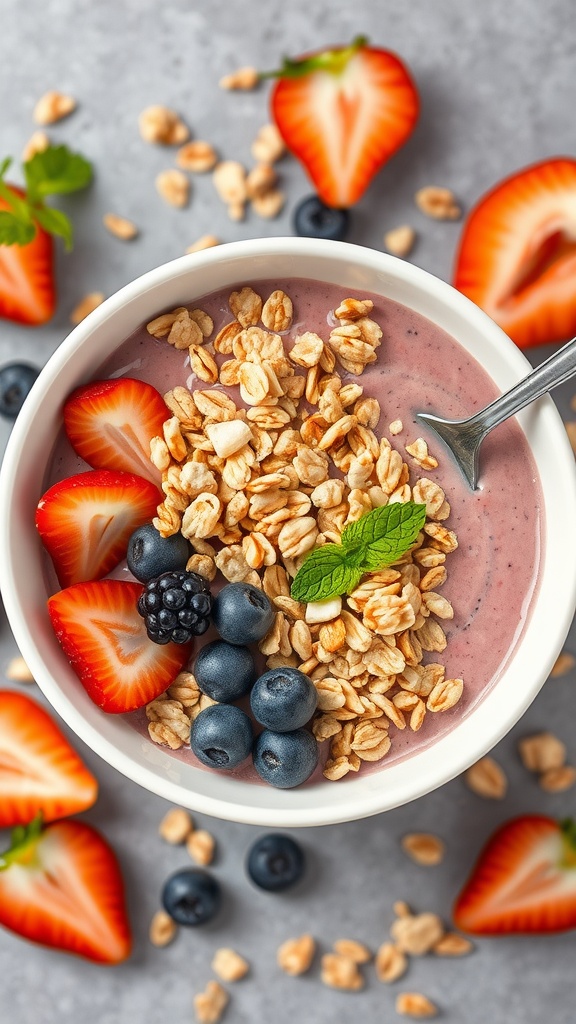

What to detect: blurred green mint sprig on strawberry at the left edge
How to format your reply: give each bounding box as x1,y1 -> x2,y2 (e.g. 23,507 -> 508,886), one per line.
0,145 -> 92,249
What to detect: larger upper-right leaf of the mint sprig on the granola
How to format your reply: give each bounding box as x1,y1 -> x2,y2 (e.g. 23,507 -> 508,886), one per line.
342,502 -> 426,572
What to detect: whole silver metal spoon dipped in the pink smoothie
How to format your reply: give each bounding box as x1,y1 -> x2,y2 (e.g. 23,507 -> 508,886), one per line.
416,338 -> 576,490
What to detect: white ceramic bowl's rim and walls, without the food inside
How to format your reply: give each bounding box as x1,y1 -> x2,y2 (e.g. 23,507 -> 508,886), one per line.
0,239 -> 576,826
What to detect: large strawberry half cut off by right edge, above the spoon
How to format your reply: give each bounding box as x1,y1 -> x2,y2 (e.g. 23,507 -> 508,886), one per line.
454,158 -> 576,348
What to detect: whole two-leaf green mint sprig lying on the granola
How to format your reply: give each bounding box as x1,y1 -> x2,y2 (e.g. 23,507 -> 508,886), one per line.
290,502 -> 426,602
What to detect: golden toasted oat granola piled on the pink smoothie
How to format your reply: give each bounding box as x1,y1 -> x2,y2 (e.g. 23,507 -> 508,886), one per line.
142,287 -> 463,780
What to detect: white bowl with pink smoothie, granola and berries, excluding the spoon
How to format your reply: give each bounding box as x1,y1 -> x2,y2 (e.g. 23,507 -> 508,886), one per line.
0,239 -> 576,826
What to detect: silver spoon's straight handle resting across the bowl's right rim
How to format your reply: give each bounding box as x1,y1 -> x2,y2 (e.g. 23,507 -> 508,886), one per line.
469,338 -> 576,435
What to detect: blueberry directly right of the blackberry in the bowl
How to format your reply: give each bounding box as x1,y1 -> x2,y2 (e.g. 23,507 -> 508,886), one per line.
212,583 -> 274,644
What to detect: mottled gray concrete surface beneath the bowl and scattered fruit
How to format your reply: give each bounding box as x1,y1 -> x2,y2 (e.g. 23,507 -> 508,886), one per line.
0,0 -> 576,1024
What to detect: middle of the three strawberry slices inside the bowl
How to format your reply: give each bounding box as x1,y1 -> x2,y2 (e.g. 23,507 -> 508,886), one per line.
36,469 -> 162,587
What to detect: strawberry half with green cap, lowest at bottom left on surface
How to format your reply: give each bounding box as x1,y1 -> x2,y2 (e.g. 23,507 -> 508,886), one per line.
0,819 -> 131,964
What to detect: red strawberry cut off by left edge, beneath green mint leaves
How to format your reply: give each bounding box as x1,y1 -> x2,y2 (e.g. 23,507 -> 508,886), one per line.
0,185 -> 56,325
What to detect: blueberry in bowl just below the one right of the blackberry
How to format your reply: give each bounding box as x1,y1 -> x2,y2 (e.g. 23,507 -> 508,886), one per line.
194,640 -> 256,703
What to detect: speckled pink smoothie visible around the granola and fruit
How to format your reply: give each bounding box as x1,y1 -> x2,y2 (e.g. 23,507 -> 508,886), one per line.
47,279 -> 543,781
